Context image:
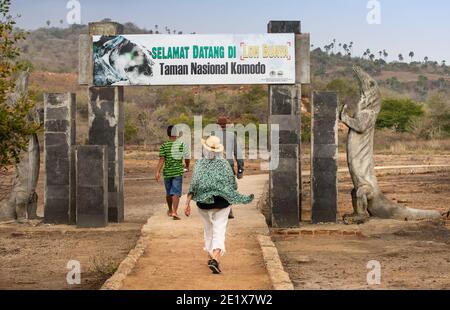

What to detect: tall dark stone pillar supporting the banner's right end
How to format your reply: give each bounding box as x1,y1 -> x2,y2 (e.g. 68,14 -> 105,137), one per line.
268,21 -> 301,228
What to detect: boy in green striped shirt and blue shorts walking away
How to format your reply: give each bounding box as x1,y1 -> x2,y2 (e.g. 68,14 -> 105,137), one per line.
155,126 -> 190,220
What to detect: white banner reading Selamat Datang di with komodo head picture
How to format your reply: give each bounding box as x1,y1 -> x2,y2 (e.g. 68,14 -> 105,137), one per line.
93,34 -> 295,86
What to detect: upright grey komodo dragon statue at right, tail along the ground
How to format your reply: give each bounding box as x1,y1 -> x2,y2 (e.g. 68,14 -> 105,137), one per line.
340,67 -> 449,224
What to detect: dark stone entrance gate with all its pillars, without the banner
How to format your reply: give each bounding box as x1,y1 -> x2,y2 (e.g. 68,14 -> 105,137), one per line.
45,21 -> 337,228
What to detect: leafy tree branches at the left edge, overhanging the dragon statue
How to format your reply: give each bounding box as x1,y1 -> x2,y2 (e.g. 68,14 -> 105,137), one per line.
0,0 -> 38,170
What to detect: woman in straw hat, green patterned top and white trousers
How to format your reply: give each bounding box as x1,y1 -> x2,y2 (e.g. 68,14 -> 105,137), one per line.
185,136 -> 254,274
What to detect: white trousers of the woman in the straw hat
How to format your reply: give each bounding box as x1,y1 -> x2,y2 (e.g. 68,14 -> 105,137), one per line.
198,207 -> 231,256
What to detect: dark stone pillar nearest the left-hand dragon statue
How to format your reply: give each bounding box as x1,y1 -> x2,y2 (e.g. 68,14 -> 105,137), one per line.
44,93 -> 76,224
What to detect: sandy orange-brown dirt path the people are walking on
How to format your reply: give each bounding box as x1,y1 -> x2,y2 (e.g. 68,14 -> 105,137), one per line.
119,175 -> 271,290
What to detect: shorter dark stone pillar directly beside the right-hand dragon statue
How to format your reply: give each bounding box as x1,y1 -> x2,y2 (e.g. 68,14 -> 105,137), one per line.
311,92 -> 338,223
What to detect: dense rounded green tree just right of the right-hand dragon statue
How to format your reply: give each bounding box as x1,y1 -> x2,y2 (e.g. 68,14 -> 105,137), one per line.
377,99 -> 425,132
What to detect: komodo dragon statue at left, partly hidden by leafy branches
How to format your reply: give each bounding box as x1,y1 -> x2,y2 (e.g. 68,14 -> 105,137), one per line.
0,72 -> 43,222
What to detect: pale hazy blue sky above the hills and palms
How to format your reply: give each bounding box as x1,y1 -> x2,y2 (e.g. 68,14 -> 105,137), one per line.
12,0 -> 450,63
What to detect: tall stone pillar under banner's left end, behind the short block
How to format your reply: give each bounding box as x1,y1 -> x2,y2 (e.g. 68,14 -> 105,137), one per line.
89,87 -> 124,223
